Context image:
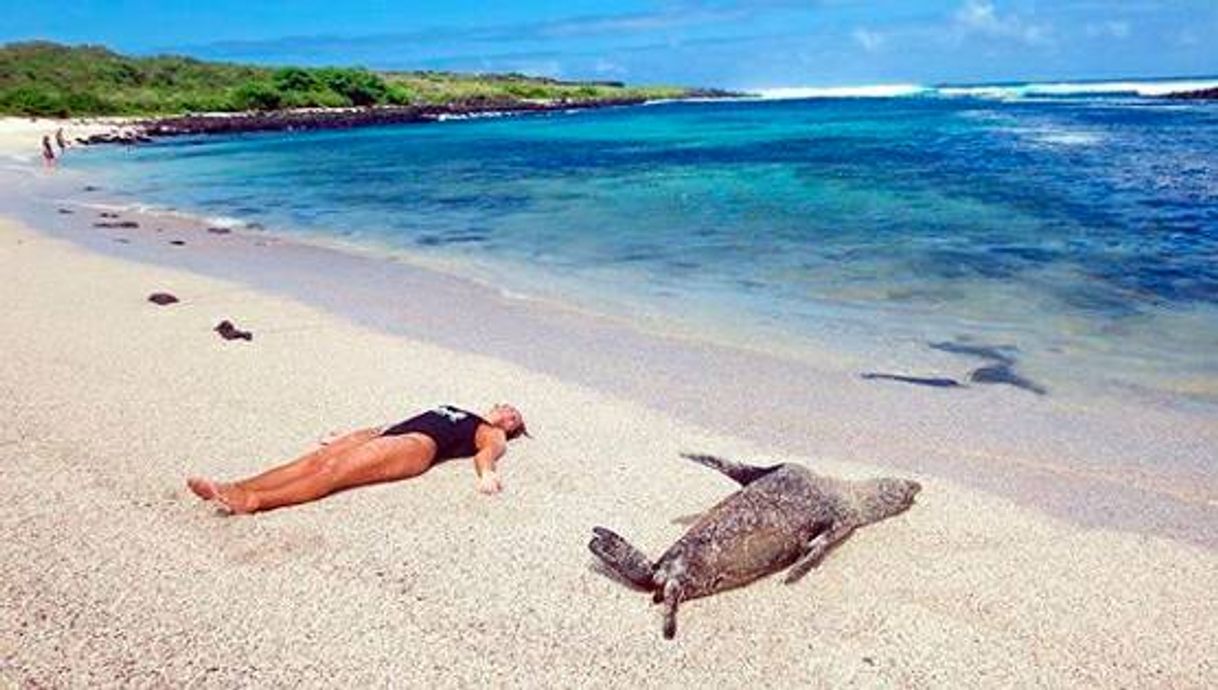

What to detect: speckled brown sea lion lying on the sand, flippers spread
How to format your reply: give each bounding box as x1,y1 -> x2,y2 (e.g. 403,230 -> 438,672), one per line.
588,454 -> 922,639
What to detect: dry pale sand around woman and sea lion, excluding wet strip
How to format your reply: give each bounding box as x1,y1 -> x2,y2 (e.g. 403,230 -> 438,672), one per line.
0,118 -> 1218,688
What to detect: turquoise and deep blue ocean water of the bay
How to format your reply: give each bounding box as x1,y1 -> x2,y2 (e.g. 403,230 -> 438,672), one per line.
73,81 -> 1218,402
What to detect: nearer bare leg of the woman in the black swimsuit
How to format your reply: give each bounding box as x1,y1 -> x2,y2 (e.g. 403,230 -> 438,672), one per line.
216,436 -> 436,512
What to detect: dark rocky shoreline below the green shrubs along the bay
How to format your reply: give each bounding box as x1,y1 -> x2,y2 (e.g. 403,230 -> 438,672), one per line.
78,91 -> 736,145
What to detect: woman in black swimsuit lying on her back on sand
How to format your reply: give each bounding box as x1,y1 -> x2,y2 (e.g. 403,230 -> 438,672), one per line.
186,404 -> 527,514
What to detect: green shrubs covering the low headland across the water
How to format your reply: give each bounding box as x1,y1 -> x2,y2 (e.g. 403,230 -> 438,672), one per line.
0,43 -> 692,117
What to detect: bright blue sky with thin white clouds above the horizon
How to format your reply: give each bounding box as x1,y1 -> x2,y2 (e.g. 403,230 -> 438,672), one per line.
0,0 -> 1218,88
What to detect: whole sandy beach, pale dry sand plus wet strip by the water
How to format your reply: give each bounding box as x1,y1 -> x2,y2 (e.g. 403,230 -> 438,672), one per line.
0,122 -> 1218,688
